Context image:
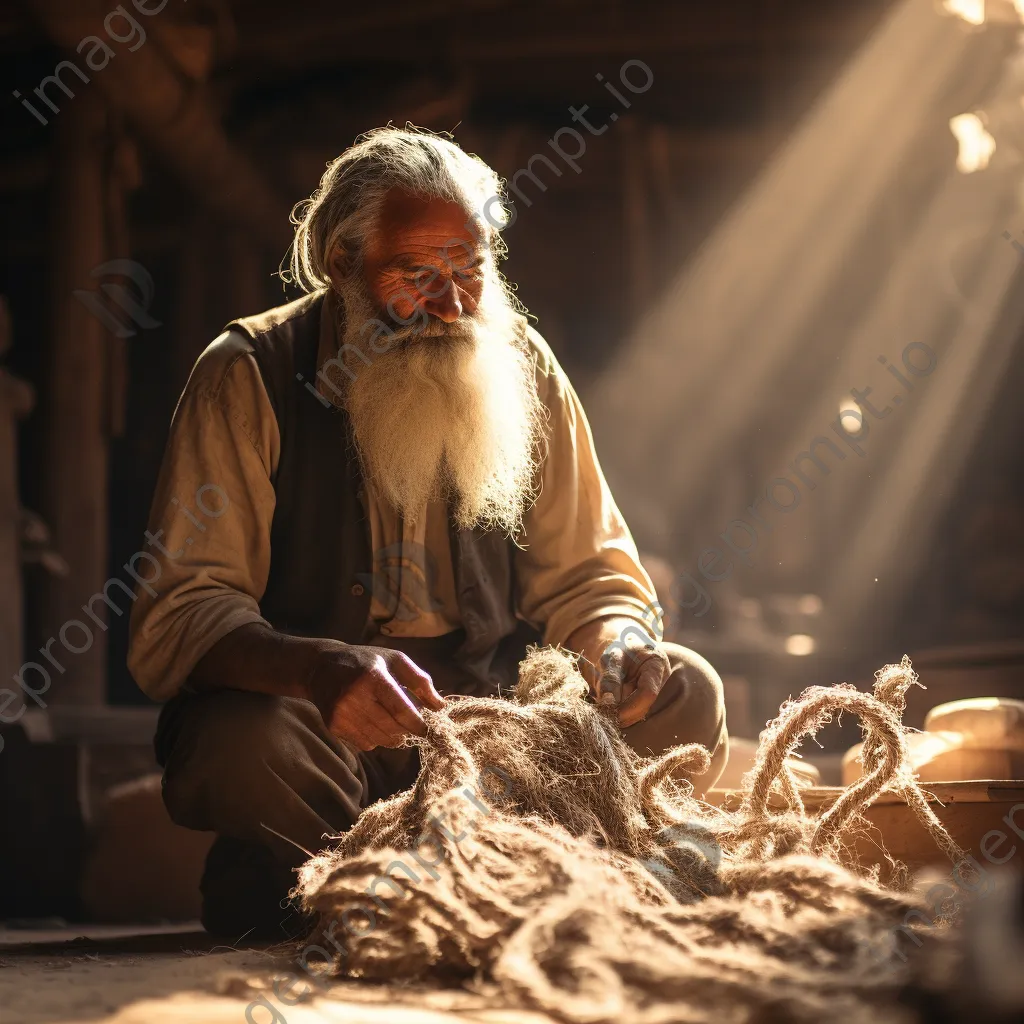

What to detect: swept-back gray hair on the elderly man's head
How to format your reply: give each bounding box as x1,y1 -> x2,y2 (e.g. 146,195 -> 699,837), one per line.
282,124 -> 509,292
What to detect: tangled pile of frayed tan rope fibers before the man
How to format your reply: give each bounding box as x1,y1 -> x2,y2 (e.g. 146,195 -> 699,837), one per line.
296,648 -> 962,1024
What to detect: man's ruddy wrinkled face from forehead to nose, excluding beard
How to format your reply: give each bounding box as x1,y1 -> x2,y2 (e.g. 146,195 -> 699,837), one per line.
333,190 -> 488,340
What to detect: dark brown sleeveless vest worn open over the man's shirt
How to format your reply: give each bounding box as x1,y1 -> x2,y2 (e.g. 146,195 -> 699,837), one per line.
228,293 -> 539,693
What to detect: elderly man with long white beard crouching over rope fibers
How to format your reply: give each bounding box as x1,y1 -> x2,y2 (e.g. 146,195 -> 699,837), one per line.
129,128 -> 727,937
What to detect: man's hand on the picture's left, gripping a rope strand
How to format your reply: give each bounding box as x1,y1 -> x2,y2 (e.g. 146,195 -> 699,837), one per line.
306,643 -> 444,751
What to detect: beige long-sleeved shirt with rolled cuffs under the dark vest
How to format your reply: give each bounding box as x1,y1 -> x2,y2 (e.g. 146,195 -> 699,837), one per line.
128,301 -> 655,700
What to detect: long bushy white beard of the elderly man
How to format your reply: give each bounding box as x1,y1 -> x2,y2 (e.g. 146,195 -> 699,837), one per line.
342,274 -> 546,537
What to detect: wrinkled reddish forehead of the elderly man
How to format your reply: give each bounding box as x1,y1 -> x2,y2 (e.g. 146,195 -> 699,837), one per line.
368,188 -> 481,264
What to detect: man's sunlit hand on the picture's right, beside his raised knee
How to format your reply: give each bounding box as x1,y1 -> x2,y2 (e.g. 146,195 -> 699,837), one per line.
566,616 -> 672,728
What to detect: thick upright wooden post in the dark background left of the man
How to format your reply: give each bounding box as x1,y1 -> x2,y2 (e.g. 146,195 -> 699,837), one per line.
41,89 -> 109,705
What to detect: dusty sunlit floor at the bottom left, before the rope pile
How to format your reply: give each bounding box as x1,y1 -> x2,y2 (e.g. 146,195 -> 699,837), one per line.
0,925 -> 548,1024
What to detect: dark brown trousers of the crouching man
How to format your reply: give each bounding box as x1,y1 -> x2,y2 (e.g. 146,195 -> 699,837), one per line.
156,644 -> 728,931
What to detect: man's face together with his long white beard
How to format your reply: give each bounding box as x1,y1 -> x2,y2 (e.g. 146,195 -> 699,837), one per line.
332,191 -> 545,535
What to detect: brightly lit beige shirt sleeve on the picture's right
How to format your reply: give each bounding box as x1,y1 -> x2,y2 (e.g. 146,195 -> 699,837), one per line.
516,329 -> 655,644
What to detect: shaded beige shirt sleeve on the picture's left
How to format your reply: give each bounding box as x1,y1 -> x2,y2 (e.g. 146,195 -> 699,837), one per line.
128,332 -> 281,700
